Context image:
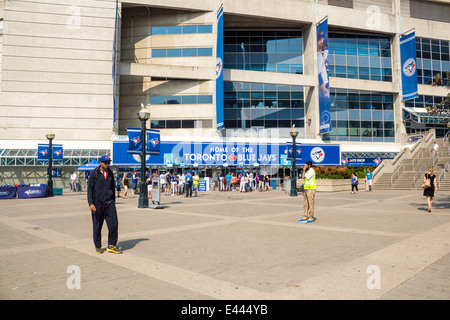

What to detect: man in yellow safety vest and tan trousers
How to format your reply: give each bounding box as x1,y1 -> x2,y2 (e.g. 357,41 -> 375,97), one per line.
298,161 -> 316,224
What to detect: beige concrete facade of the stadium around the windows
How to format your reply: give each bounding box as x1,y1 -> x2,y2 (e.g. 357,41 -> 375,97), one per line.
0,0 -> 450,156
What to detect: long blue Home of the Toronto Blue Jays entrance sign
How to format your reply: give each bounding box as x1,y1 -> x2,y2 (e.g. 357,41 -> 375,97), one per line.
112,141 -> 341,167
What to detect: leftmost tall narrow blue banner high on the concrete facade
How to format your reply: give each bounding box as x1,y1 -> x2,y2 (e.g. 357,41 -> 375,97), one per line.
216,5 -> 223,130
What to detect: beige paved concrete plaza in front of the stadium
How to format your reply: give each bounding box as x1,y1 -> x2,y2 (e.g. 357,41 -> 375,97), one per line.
0,186 -> 450,300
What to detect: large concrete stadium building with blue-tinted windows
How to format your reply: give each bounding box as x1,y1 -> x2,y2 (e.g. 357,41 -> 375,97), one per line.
0,0 -> 450,184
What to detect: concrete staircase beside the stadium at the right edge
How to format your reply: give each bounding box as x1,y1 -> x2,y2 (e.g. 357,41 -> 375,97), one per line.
374,132 -> 450,191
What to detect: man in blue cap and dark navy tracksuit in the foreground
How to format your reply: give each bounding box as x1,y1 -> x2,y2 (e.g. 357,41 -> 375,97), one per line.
87,155 -> 122,253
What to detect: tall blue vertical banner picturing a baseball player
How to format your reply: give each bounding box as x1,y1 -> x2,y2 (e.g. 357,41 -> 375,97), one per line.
317,19 -> 331,133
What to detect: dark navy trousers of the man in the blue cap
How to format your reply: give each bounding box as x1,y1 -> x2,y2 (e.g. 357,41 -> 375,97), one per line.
91,202 -> 119,248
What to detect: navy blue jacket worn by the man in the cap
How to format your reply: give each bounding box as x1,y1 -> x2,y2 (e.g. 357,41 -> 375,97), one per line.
87,167 -> 116,205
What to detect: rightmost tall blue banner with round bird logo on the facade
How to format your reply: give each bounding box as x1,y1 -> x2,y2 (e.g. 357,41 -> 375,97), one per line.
400,32 -> 419,100
